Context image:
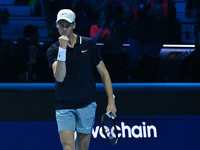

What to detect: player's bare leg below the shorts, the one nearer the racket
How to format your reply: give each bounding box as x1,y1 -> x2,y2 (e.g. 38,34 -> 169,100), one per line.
77,133 -> 91,150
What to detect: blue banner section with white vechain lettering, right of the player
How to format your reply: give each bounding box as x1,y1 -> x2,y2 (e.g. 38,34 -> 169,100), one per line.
91,116 -> 200,150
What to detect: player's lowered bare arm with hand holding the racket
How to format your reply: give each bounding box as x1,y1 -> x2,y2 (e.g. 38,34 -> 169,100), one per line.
97,61 -> 117,117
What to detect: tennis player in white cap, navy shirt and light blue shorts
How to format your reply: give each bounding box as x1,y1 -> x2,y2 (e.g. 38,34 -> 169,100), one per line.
47,9 -> 117,150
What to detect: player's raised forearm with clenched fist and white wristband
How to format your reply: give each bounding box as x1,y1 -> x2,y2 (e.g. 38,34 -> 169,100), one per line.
52,36 -> 69,82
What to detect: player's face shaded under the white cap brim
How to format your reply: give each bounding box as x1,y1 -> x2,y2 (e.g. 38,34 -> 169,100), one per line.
56,20 -> 75,37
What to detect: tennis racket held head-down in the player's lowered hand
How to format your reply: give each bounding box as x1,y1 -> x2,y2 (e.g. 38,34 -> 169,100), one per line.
101,112 -> 118,145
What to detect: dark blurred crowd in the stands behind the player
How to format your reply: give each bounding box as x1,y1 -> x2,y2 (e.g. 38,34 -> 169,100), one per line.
0,0 -> 198,82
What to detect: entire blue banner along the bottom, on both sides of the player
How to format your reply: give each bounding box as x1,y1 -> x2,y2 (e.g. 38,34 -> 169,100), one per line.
0,116 -> 200,150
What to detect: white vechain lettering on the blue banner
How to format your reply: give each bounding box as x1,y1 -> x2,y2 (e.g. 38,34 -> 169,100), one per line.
92,122 -> 157,138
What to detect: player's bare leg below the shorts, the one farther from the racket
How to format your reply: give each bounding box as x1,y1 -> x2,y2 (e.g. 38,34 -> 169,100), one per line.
59,130 -> 75,150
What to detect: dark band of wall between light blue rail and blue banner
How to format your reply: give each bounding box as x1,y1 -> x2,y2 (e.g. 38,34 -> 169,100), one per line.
0,88 -> 200,121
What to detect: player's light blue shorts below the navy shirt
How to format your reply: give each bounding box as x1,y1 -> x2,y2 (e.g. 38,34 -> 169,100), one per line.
56,102 -> 97,134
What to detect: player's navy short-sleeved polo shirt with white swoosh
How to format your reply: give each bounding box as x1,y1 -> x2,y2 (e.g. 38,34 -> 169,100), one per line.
47,36 -> 102,109
